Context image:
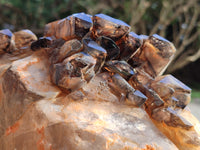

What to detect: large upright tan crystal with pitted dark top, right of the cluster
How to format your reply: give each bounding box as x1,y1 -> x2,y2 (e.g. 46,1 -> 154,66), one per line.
132,35 -> 176,77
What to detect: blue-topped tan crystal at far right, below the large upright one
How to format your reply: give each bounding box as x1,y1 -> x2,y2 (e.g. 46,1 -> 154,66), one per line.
150,75 -> 191,108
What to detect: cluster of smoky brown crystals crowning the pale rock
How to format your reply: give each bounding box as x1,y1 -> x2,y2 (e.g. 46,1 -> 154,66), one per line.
0,13 -> 200,148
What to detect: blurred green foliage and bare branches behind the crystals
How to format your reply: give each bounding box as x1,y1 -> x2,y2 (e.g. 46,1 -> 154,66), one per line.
0,0 -> 200,116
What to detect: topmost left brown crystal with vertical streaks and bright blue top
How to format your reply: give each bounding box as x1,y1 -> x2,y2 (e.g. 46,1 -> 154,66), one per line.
44,13 -> 92,40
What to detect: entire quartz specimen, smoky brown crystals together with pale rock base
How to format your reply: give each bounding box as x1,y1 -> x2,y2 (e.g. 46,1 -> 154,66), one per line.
0,13 -> 200,150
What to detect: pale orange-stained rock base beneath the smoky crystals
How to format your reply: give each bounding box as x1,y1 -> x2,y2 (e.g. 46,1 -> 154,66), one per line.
0,51 -> 177,150
